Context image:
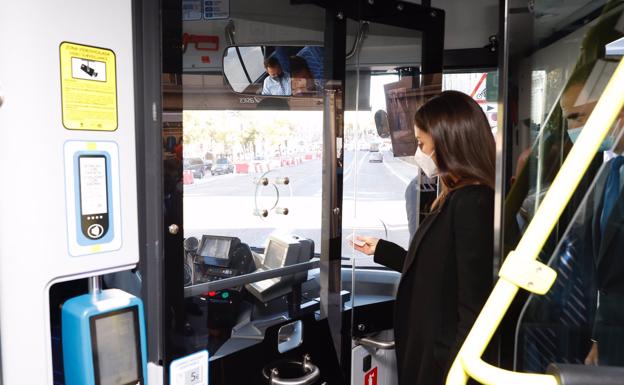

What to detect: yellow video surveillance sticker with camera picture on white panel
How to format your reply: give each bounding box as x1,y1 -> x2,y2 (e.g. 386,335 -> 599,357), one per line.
60,42 -> 117,131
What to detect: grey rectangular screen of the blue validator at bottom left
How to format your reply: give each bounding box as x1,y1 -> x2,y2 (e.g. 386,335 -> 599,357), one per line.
91,306 -> 142,385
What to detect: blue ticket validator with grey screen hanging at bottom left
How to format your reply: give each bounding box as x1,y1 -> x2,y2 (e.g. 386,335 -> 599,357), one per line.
62,277 -> 146,385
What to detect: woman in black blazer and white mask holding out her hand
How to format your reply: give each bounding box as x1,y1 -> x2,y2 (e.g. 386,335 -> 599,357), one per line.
354,91 -> 495,385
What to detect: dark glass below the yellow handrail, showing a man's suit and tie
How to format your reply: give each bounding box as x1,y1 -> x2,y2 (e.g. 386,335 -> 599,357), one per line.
515,114 -> 624,372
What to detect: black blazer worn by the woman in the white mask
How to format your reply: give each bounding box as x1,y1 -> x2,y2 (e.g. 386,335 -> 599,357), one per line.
375,185 -> 494,385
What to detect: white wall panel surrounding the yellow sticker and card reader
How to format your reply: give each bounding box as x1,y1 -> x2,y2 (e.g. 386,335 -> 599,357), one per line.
0,0 -> 138,385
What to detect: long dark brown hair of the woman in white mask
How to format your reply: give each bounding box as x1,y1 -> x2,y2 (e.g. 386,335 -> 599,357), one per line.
414,91 -> 496,208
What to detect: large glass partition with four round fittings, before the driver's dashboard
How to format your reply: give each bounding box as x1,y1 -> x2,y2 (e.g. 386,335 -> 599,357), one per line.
163,0 -> 338,383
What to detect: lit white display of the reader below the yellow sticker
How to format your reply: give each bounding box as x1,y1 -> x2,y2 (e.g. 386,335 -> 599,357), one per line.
78,156 -> 108,215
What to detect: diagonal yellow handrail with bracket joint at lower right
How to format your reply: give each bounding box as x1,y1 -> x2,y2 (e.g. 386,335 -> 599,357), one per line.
446,54 -> 624,385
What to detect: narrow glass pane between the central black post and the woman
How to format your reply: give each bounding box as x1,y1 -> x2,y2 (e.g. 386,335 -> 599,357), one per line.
342,22 -> 424,383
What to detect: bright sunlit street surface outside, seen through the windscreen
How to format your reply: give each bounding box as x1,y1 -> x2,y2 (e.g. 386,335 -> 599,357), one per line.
184,151 -> 417,266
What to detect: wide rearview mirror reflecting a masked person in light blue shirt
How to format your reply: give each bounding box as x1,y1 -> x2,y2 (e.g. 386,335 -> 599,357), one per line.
223,45 -> 325,98
